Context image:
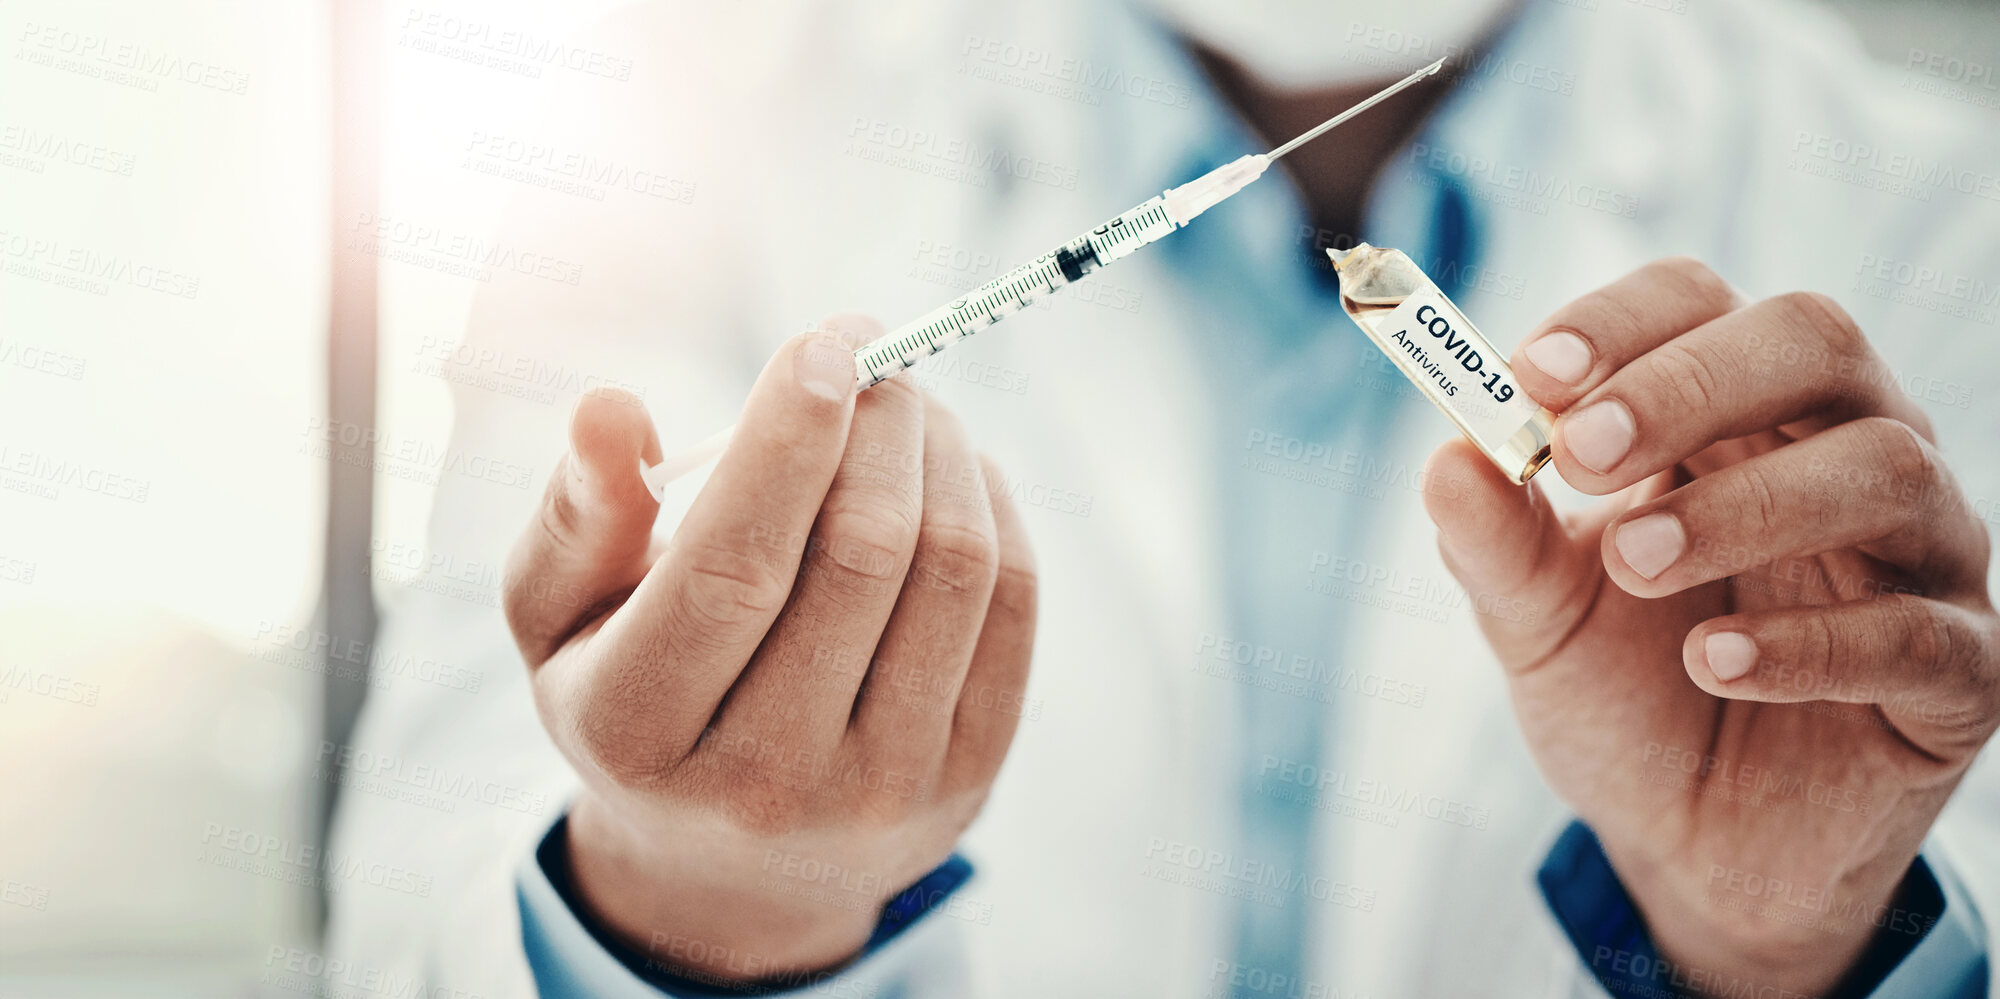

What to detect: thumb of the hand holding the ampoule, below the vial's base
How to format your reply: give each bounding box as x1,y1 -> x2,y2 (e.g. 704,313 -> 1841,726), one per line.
1424,438 -> 1604,673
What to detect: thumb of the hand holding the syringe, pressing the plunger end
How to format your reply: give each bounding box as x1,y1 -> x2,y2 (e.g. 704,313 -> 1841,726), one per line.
502,388 -> 660,667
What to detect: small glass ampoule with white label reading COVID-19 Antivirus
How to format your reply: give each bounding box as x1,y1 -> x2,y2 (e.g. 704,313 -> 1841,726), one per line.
1326,244 -> 1556,486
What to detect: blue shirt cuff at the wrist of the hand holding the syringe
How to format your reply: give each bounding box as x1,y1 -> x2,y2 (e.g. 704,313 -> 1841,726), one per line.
516,815 -> 972,999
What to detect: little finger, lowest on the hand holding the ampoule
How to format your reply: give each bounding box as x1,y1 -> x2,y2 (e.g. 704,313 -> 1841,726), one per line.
1682,593 -> 2000,757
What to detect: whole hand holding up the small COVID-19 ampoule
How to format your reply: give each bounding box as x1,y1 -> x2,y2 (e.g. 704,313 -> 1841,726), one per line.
1426,260 -> 2000,995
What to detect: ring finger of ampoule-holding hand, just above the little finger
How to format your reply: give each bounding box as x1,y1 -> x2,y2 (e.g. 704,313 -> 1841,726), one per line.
1602,418 -> 1988,599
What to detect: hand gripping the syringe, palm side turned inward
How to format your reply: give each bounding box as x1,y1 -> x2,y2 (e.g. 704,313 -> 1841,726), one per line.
504,320 -> 1036,981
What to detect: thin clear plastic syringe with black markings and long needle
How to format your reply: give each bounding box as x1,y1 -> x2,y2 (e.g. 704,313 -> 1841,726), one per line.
642,60 -> 1444,500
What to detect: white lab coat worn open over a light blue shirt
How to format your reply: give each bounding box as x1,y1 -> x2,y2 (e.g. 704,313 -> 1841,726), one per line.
328,0 -> 2000,997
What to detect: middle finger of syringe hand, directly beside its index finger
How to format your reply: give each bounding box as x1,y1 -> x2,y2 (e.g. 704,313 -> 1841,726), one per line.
716,343 -> 924,747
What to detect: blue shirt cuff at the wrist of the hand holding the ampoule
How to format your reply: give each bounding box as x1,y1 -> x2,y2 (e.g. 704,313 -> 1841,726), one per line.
1536,821 -> 1988,999
